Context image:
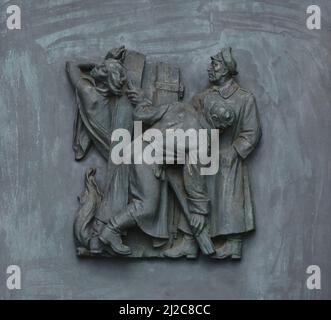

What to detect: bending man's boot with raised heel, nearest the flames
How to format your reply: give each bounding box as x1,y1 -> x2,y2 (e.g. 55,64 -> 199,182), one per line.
99,212 -> 136,255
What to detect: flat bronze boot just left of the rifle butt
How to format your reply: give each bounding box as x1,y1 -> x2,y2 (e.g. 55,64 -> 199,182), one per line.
163,234 -> 199,259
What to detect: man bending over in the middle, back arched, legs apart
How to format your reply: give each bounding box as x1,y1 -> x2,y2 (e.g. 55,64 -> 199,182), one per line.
100,83 -> 234,257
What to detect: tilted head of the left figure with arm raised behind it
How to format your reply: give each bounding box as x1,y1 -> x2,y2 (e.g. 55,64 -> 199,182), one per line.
90,58 -> 126,95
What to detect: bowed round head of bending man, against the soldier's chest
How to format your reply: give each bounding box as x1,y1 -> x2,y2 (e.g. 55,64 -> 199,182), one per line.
206,102 -> 235,130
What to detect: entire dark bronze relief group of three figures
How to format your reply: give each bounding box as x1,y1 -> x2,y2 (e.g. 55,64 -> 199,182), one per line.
66,47 -> 261,259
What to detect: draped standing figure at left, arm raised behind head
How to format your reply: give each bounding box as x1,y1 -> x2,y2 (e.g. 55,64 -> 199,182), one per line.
66,47 -> 145,253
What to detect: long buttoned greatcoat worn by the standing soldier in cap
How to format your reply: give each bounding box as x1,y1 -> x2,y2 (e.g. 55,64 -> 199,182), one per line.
192,79 -> 261,237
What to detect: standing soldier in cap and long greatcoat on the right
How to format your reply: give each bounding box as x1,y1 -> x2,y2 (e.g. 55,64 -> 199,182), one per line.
167,48 -> 261,259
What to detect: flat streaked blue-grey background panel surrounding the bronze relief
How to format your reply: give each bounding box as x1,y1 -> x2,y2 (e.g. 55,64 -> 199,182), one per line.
0,0 -> 331,299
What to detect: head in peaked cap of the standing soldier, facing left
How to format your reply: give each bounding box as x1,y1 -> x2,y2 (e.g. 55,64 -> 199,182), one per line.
208,47 -> 238,84
